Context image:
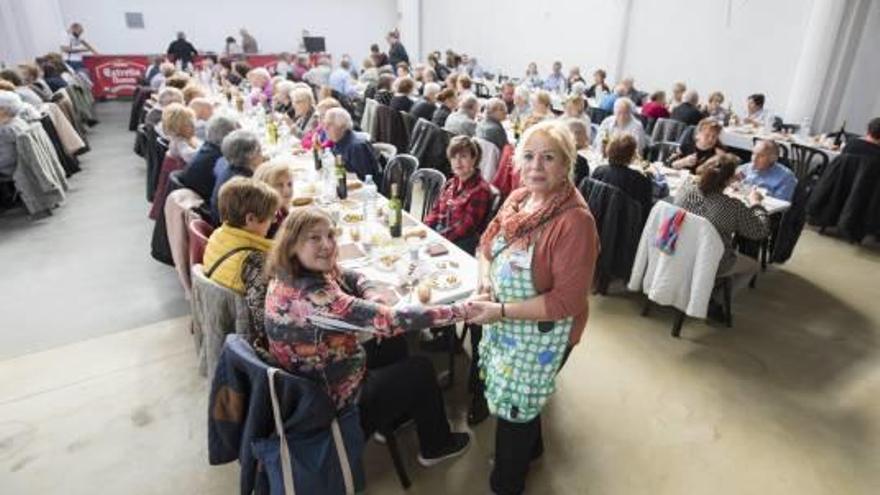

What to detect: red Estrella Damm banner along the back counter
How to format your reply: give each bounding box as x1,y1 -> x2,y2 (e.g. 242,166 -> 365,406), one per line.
83,54 -> 288,100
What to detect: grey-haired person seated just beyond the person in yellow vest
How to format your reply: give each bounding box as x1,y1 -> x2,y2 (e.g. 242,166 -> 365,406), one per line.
211,129 -> 262,224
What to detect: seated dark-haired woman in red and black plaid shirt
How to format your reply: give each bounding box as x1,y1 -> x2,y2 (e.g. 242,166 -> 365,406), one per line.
425,136 -> 492,254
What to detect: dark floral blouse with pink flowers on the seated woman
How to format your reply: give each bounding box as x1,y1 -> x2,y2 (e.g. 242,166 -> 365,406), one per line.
265,271 -> 465,409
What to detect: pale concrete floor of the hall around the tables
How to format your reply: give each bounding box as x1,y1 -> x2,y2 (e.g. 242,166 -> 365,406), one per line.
0,104 -> 880,495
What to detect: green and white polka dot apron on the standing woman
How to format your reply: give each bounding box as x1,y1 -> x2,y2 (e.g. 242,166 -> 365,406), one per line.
479,234 -> 572,423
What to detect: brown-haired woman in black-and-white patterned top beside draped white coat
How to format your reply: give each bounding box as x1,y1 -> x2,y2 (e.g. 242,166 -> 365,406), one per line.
675,153 -> 770,316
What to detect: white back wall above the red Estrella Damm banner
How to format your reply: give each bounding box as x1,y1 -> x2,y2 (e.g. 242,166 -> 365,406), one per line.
57,0 -> 396,61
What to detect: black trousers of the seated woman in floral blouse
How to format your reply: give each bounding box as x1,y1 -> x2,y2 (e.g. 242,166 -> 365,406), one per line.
358,356 -> 450,457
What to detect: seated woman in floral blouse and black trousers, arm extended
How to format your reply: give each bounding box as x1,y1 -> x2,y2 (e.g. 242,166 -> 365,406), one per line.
265,208 -> 470,466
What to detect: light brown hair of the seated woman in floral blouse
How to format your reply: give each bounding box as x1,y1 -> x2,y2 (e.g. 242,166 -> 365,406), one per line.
266,207 -> 333,278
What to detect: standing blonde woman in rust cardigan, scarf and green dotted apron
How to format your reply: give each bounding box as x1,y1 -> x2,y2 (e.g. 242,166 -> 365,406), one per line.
468,120 -> 599,494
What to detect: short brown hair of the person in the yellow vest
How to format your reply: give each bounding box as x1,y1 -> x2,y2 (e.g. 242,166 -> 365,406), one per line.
217,177 -> 281,228
